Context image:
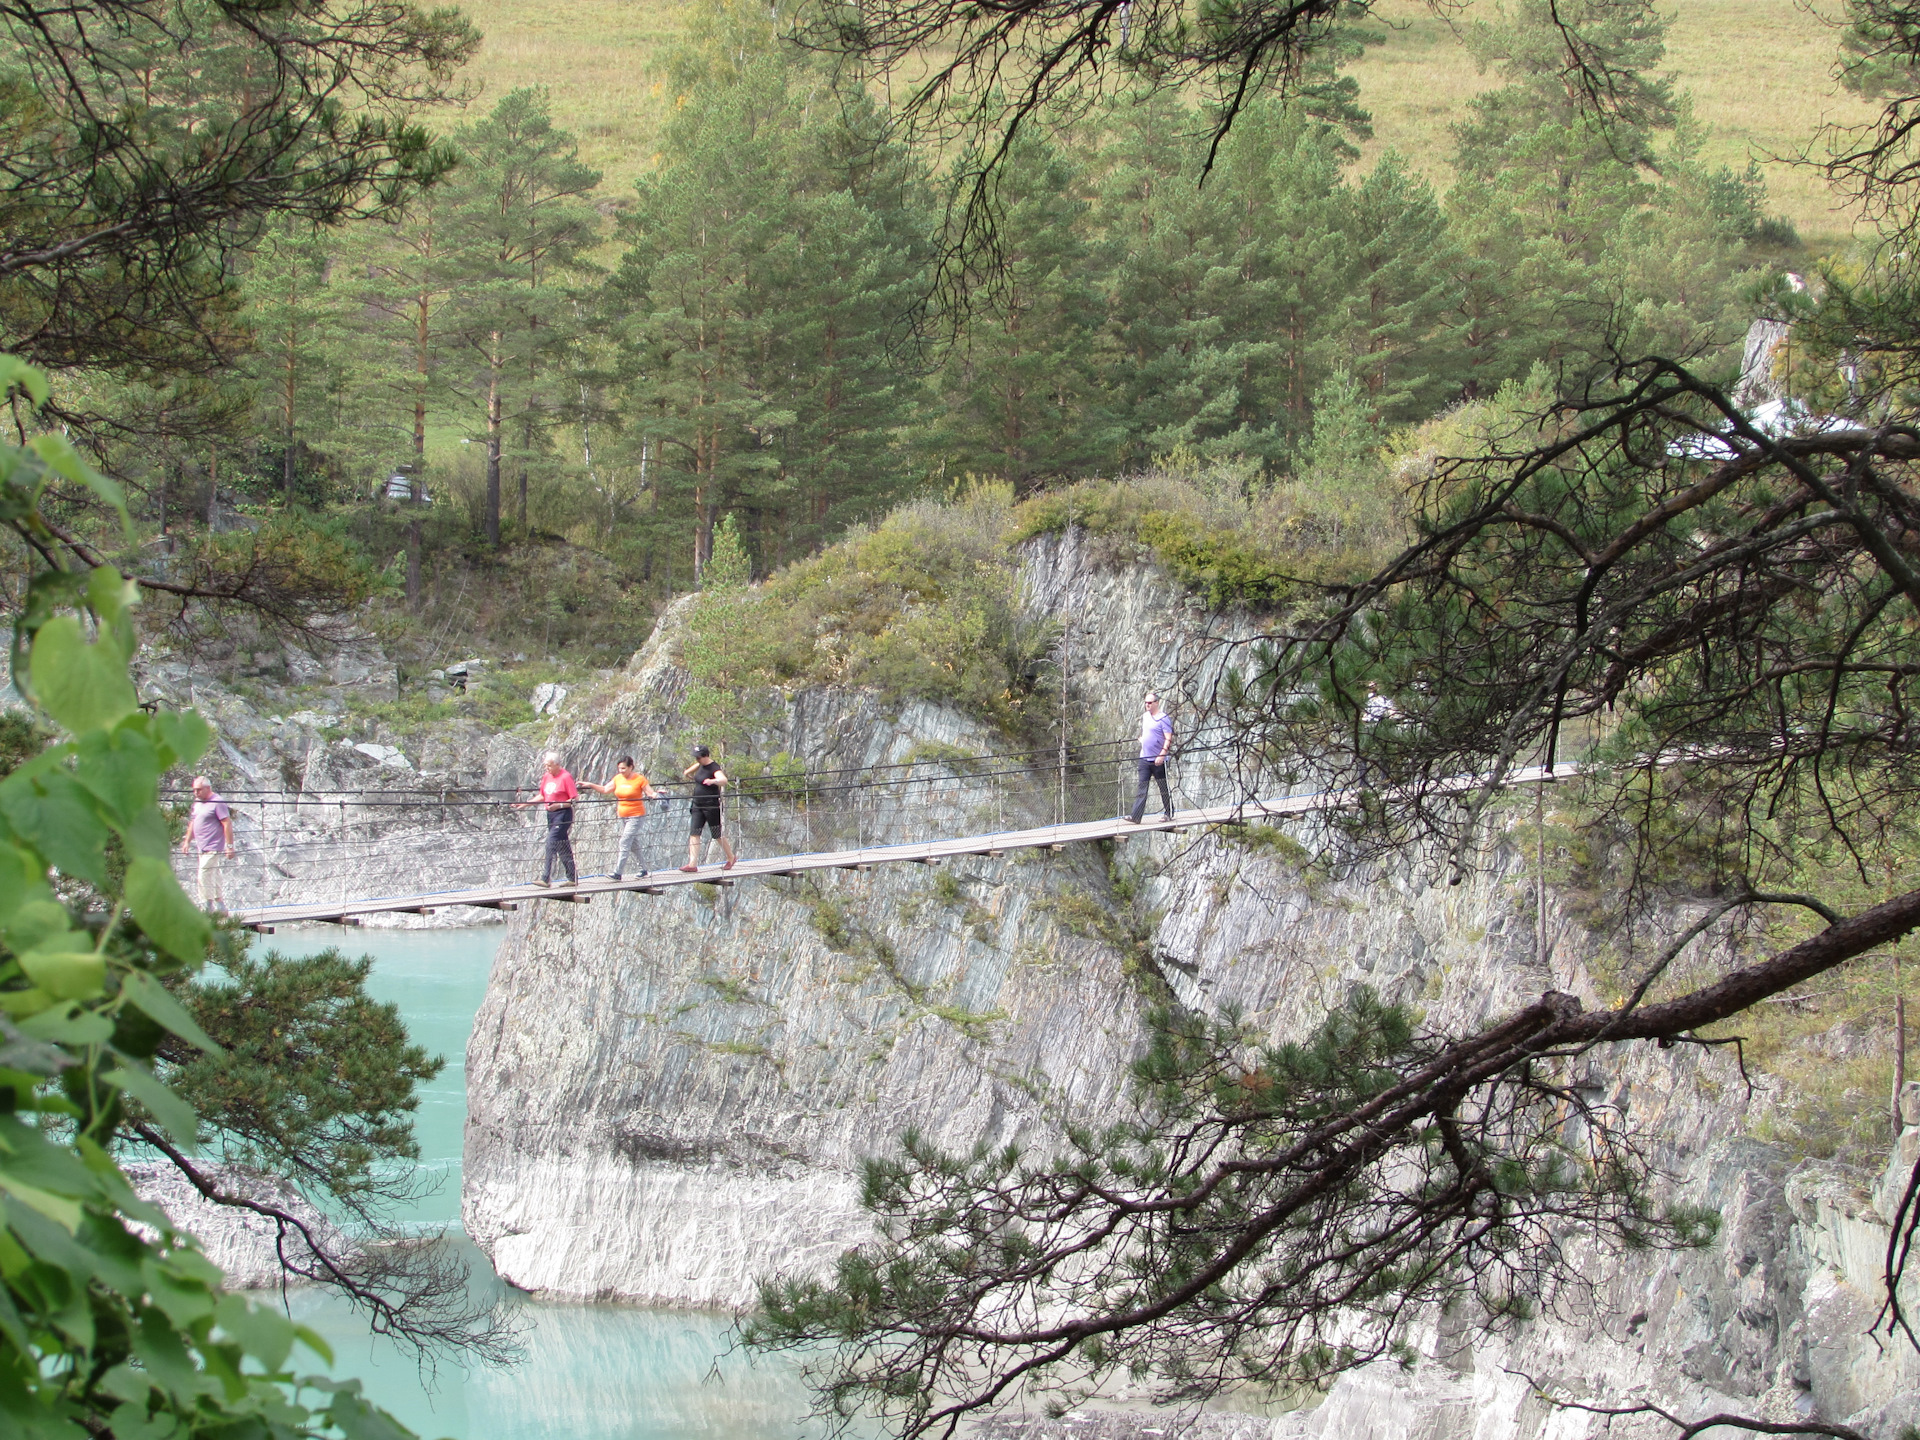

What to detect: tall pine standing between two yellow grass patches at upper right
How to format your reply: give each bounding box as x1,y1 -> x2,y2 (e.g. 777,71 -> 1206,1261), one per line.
1446,0 -> 1753,396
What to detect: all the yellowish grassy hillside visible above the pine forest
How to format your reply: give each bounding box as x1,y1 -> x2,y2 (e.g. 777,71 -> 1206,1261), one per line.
445,0 -> 1870,242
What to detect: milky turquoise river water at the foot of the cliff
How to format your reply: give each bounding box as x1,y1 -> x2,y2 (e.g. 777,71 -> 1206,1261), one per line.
255,925 -> 856,1440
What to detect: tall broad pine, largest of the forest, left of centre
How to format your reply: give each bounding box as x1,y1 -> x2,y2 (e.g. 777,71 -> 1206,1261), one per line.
605,22 -> 929,576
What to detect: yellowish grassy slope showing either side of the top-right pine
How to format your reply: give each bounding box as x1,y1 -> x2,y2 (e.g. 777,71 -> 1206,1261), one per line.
1354,0 -> 1874,244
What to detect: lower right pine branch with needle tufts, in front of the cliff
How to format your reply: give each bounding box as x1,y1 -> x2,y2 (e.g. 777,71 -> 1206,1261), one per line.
749,891 -> 1920,1436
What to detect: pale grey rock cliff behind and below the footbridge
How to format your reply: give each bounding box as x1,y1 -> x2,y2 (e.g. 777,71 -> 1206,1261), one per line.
453,536 -> 1920,1440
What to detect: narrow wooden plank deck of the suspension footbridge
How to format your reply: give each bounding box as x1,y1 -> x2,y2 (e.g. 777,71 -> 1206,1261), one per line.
232,762 -> 1580,935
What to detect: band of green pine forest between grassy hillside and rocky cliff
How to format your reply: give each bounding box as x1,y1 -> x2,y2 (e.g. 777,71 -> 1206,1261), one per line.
0,0 -> 1809,659
